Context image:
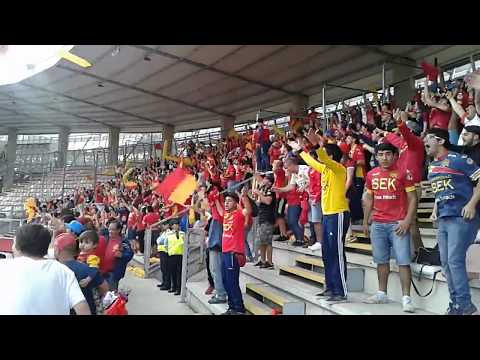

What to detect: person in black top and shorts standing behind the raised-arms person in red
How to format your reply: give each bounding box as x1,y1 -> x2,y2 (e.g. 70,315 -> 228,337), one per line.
254,175 -> 275,269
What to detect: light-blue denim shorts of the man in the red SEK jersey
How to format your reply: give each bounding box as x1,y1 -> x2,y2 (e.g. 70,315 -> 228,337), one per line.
370,221 -> 411,266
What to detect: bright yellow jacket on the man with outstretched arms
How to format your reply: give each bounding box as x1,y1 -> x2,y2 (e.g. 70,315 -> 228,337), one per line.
300,148 -> 349,215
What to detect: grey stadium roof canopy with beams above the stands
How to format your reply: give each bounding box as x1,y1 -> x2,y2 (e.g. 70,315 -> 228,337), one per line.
0,45 -> 480,134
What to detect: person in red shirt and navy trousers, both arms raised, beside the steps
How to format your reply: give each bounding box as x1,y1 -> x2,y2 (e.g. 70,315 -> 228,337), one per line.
215,188 -> 252,315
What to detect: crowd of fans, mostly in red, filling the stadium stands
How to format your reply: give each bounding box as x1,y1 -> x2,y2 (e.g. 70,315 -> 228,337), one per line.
0,67 -> 480,314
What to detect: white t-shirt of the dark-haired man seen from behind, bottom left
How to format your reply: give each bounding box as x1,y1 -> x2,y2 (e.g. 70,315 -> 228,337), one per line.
0,256 -> 85,315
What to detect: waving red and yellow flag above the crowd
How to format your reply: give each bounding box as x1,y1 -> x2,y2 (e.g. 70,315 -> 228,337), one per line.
154,168 -> 197,204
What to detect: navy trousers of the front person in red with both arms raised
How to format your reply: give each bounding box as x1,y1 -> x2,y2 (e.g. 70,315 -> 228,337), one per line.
222,253 -> 245,313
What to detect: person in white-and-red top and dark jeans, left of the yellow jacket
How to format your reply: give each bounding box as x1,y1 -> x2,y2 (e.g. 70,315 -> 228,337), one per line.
272,157 -> 306,246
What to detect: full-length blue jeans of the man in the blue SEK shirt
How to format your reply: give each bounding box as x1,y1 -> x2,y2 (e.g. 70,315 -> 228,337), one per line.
437,217 -> 478,311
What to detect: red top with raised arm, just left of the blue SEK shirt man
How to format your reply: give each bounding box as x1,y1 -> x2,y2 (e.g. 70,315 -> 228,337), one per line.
385,123 -> 425,184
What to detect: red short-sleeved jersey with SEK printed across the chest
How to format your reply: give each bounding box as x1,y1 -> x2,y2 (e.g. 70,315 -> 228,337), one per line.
365,164 -> 415,223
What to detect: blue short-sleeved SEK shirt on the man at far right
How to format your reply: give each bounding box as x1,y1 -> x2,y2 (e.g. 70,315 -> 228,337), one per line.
428,151 -> 480,218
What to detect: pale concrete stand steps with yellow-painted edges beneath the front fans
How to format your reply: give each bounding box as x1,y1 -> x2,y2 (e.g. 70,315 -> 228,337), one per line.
187,183 -> 480,315
